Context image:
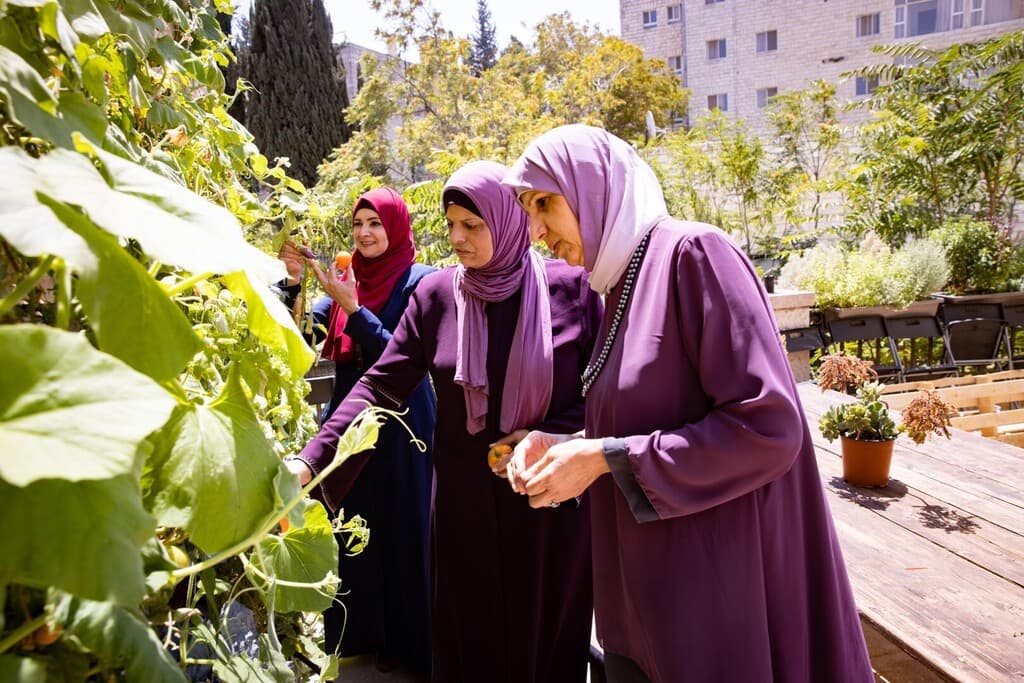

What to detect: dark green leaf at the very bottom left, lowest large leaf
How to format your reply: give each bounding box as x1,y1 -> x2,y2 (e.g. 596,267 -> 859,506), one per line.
54,595 -> 188,683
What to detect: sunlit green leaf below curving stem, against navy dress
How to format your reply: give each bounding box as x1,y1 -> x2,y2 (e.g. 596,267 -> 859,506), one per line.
250,499 -> 338,612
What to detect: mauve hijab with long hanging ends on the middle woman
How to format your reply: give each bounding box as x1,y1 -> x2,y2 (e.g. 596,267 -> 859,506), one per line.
441,161 -> 554,434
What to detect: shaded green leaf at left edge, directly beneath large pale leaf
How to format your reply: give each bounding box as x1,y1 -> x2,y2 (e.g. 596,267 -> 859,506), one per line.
0,479 -> 156,605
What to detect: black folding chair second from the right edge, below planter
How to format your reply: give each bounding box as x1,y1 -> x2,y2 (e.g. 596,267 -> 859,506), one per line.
939,301 -> 1013,370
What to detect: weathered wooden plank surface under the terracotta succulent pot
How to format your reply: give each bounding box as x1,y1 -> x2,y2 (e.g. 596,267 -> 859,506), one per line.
800,382 -> 1024,683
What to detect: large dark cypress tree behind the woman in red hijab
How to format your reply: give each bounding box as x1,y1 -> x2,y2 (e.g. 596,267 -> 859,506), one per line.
246,0 -> 349,185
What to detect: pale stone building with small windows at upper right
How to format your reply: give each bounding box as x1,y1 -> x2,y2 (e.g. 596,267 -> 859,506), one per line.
620,0 -> 1024,132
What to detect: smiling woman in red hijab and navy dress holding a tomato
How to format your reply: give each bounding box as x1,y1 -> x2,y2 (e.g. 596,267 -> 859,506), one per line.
282,187 -> 437,673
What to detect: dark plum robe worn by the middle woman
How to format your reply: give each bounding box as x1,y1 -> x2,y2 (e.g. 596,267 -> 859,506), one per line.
299,260 -> 601,683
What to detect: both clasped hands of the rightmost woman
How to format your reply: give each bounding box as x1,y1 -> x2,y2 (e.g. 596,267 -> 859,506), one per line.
509,432 -> 609,508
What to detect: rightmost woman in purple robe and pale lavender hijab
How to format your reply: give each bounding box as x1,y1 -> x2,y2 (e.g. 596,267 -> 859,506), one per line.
504,125 -> 872,683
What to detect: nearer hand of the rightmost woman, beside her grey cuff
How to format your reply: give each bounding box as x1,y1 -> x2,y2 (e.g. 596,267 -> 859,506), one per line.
517,438 -> 609,508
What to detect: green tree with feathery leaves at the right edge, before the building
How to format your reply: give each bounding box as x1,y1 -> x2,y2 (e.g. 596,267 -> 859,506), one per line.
856,32 -> 1024,241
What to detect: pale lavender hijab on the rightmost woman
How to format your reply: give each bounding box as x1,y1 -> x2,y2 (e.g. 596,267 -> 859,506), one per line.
502,124 -> 669,294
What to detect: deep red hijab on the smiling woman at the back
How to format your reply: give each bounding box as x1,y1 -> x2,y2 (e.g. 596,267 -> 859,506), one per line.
324,187 -> 416,362
